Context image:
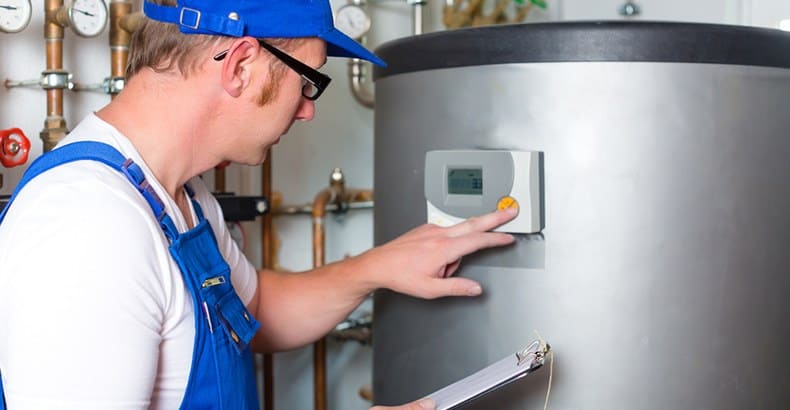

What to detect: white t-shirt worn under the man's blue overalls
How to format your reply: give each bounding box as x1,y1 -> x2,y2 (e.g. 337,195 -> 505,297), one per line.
0,115 -> 257,410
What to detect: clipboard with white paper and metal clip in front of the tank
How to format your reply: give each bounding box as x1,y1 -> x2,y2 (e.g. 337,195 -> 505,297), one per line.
428,340 -> 549,410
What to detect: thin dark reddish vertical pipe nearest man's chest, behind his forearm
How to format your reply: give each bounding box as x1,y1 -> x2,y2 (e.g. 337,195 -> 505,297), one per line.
261,150 -> 274,410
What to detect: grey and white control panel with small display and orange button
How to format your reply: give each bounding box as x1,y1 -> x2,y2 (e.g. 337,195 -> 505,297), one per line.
425,150 -> 545,234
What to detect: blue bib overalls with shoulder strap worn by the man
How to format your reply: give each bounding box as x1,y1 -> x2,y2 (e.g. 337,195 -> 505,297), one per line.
0,142 -> 260,410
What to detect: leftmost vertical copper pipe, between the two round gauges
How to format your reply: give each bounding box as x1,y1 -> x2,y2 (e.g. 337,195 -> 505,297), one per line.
39,0 -> 68,152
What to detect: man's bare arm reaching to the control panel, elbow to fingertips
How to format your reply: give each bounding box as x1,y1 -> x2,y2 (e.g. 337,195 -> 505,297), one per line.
249,210 -> 515,351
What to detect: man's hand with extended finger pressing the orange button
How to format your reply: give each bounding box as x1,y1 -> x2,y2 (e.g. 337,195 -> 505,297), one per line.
360,209 -> 516,299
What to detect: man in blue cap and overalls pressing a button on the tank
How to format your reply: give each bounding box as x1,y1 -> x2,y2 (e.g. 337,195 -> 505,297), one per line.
0,0 -> 514,410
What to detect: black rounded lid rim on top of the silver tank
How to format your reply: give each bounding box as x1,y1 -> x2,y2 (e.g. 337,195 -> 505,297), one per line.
374,21 -> 790,78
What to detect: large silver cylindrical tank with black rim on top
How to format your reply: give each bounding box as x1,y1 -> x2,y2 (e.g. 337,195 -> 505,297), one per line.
373,22 -> 790,410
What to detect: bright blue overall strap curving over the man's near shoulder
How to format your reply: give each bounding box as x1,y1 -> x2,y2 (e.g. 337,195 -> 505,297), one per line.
0,141 -> 178,240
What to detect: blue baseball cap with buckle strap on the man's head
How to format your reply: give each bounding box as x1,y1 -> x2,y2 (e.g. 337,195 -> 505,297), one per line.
143,0 -> 387,67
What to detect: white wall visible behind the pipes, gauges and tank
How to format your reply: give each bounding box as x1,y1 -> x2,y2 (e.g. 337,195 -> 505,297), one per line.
0,0 -> 790,410
